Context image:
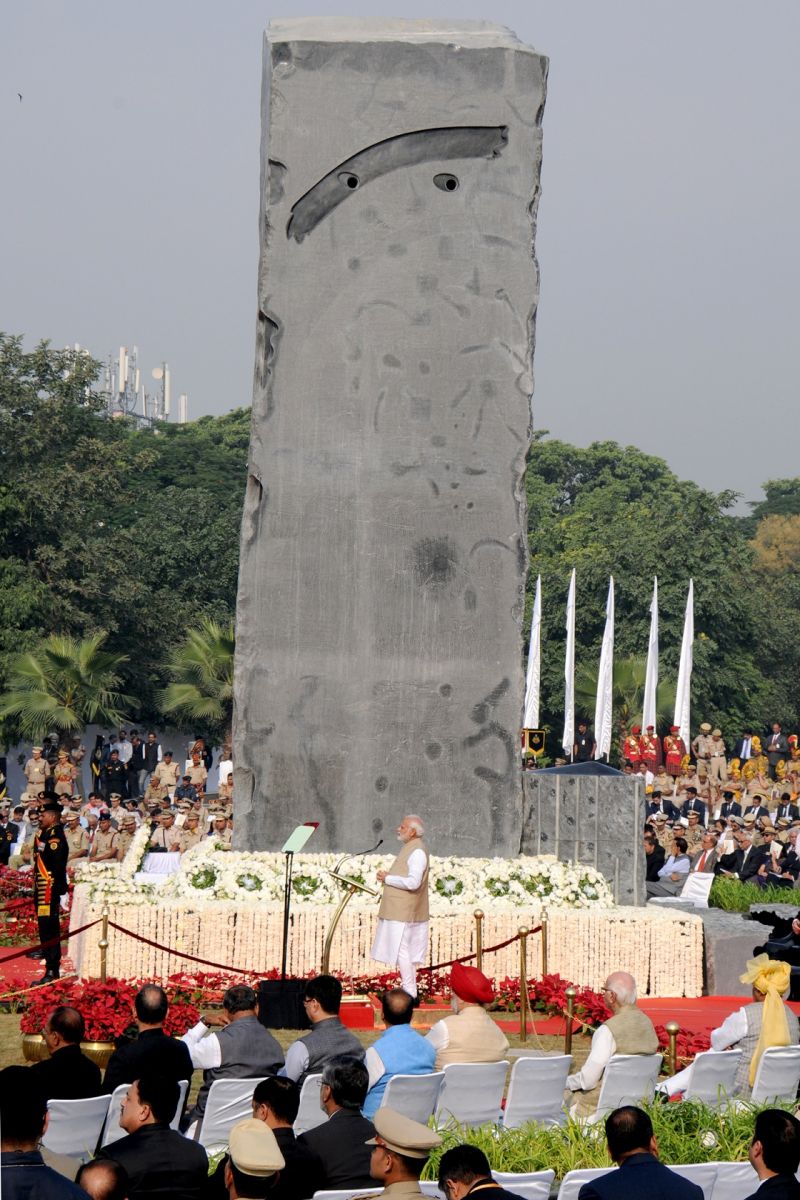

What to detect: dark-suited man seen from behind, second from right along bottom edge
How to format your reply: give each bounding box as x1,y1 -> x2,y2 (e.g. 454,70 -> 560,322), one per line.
578,1105 -> 703,1200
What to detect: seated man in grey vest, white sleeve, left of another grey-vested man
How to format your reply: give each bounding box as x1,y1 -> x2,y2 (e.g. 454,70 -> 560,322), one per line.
182,984 -> 283,1126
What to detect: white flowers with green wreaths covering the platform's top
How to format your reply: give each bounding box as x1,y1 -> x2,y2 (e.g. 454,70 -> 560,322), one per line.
79,829 -> 614,916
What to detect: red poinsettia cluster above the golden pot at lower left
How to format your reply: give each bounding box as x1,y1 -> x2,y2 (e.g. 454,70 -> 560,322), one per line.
19,979 -> 200,1042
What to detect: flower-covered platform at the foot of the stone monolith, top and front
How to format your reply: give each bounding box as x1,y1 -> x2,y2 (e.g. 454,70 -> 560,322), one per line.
70,834 -> 703,996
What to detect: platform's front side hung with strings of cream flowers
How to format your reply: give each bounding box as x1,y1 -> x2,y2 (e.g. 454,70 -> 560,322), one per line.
70,883 -> 703,997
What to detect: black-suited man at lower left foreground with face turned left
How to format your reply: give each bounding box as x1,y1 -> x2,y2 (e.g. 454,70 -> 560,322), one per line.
97,1074 -> 209,1200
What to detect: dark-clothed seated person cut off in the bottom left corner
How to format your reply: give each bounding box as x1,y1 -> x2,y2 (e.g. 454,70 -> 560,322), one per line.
0,1067 -> 86,1200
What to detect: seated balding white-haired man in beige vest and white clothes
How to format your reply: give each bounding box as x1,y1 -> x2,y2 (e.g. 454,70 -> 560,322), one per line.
566,971 -> 658,1117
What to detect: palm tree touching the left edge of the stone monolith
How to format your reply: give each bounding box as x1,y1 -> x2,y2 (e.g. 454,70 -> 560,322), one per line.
161,618 -> 236,743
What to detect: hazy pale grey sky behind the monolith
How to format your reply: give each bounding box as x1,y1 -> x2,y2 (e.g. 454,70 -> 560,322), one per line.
0,0 -> 800,498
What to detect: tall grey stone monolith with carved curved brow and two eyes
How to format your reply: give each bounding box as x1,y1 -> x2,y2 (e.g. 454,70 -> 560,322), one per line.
234,19 -> 547,854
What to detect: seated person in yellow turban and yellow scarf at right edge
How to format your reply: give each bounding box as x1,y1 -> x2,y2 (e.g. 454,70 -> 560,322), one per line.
657,954 -> 800,1096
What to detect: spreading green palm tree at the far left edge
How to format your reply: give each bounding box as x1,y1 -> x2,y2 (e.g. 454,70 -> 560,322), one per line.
0,632 -> 133,740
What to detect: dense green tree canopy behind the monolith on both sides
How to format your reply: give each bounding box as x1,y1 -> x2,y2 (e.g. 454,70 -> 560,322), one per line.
0,334 -> 800,738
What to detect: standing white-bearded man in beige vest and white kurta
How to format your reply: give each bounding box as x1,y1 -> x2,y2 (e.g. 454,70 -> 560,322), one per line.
371,816 -> 428,996
